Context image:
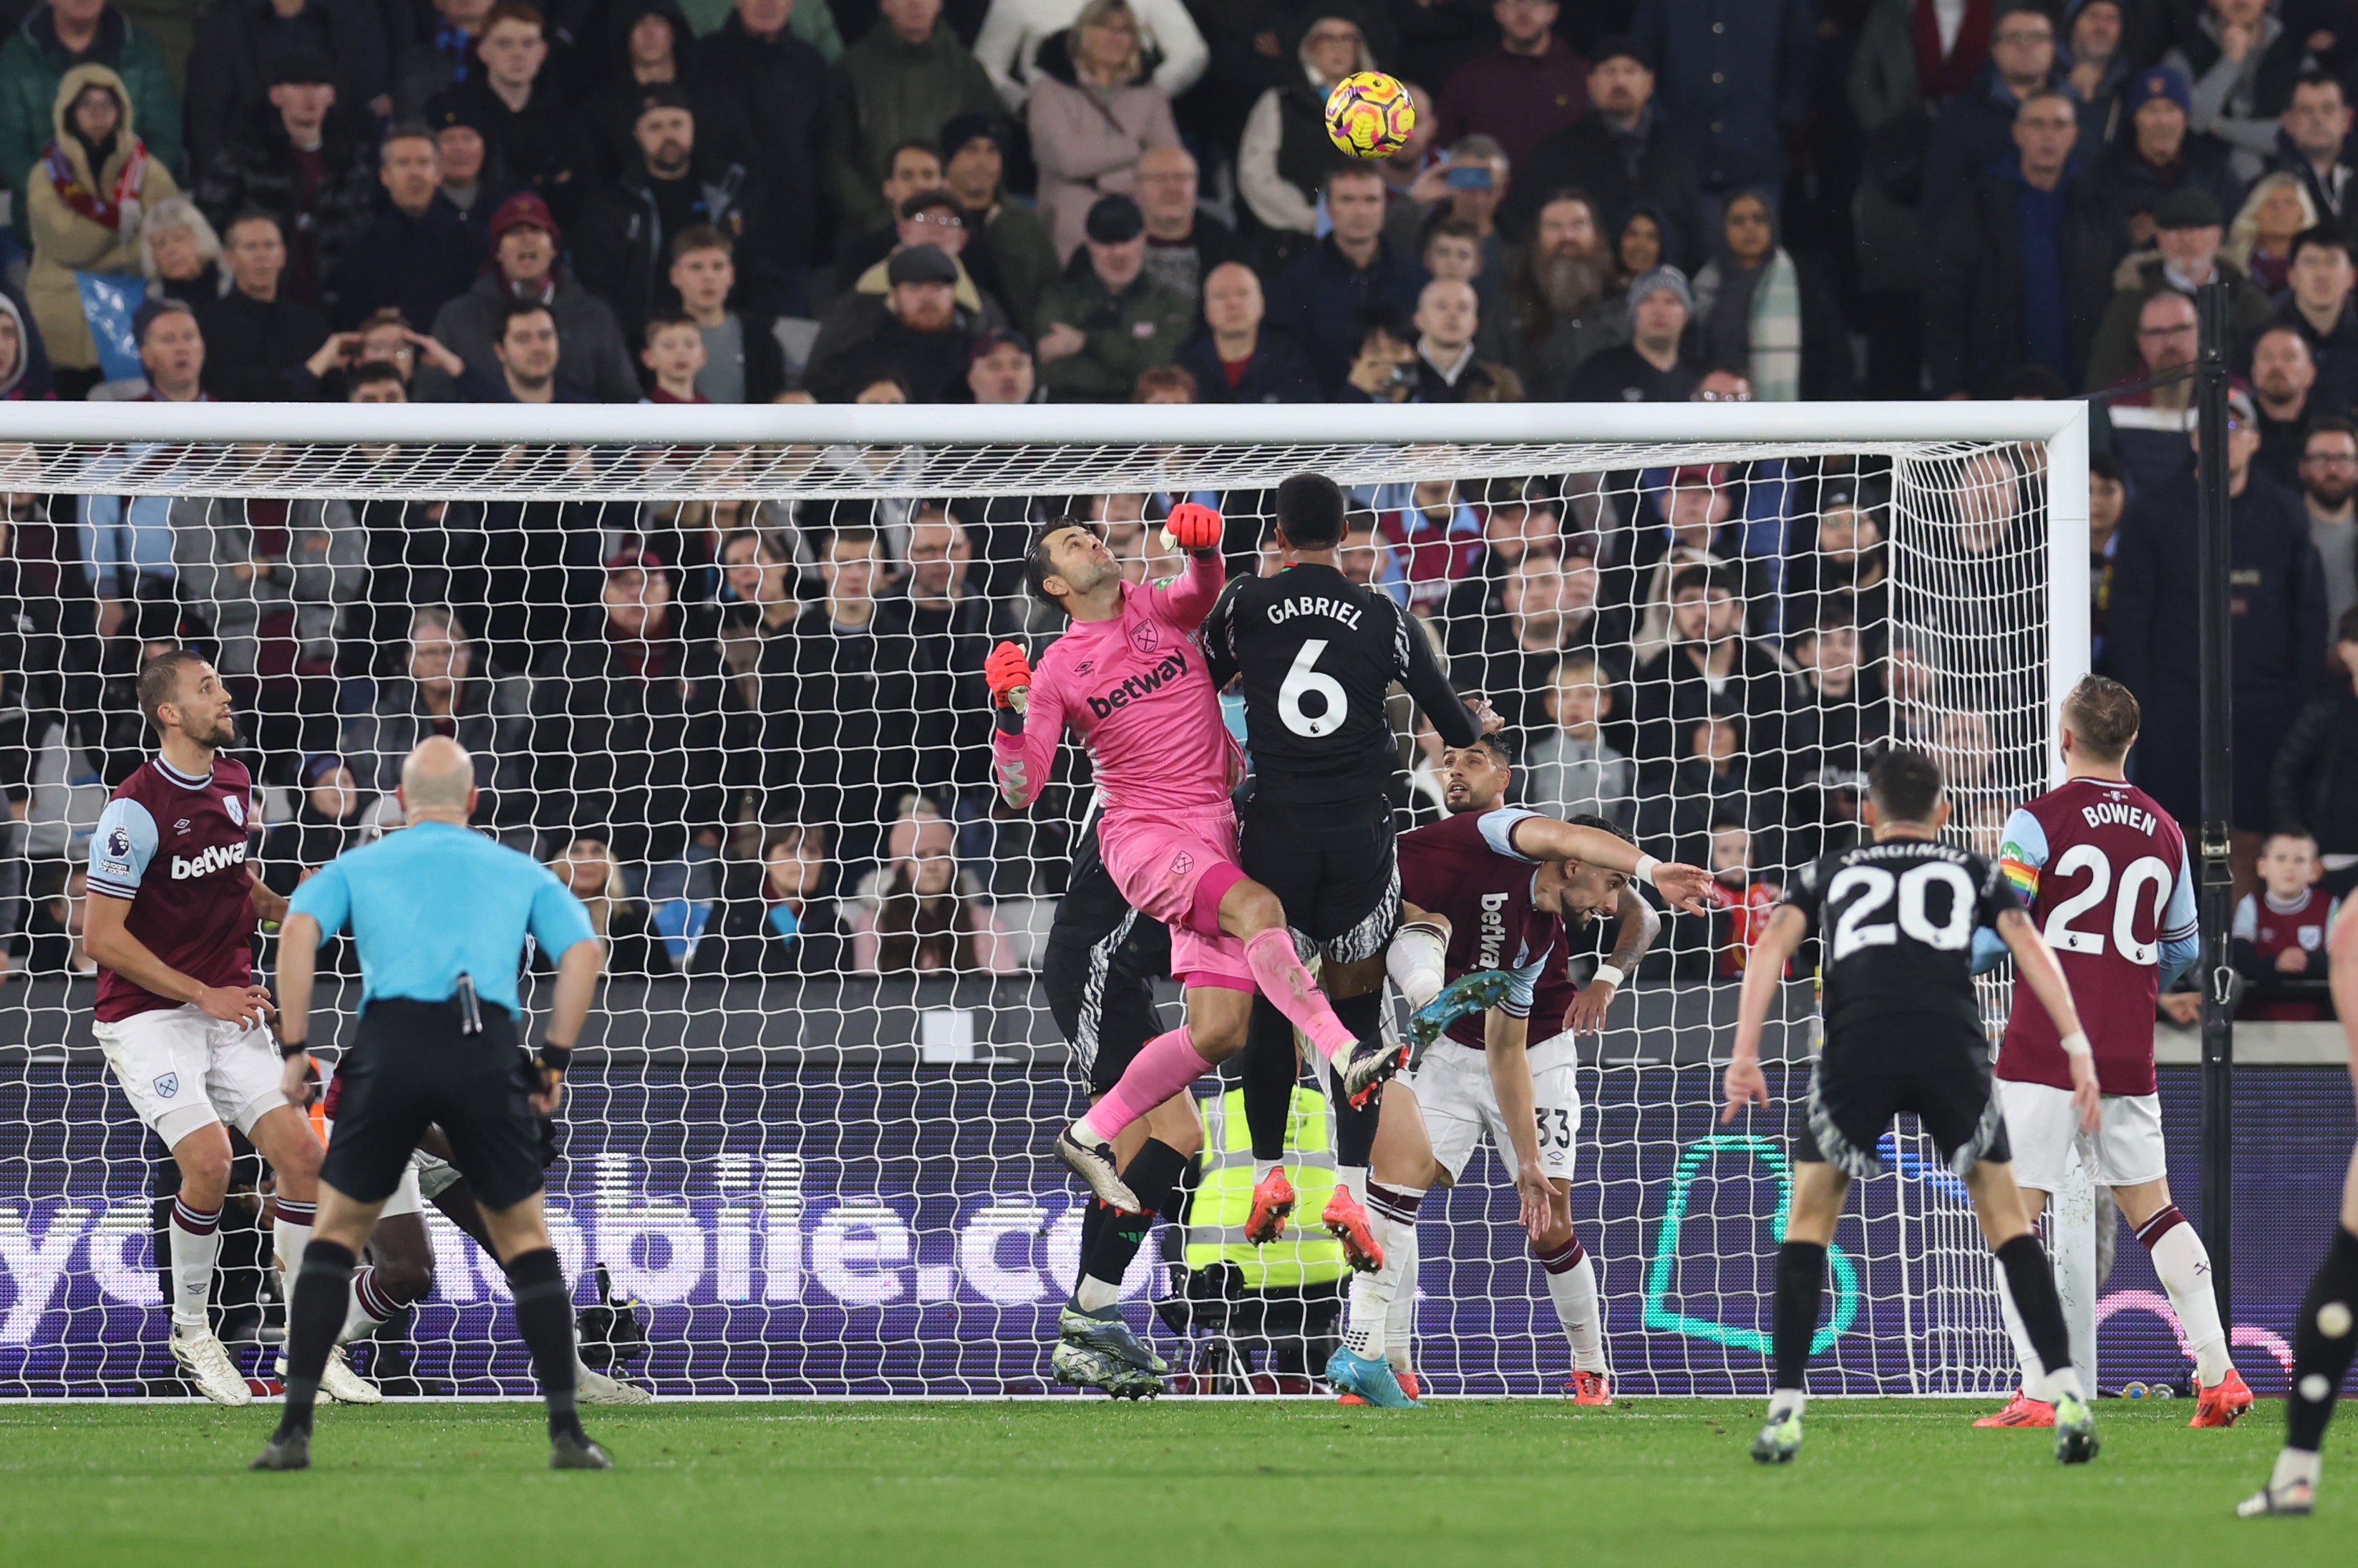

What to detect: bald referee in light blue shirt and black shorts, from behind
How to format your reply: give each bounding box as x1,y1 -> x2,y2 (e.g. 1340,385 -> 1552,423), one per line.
252,736 -> 613,1469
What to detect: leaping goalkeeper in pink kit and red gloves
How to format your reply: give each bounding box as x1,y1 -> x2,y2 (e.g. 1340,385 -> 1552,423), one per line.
986,502 -> 1403,1212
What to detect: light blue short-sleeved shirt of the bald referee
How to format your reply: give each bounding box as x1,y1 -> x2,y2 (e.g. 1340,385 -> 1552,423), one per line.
290,823 -> 596,1014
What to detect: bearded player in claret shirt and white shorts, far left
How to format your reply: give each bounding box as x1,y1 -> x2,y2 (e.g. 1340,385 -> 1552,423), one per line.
85,648 -> 379,1406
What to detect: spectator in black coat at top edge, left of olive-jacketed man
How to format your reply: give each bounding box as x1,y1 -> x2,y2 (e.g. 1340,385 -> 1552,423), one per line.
696,0 -> 830,316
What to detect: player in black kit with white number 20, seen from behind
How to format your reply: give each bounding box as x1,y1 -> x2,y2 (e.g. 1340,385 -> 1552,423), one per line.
1719,750 -> 2103,1464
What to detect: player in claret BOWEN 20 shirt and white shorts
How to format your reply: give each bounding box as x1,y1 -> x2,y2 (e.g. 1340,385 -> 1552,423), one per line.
1974,674 -> 2252,1426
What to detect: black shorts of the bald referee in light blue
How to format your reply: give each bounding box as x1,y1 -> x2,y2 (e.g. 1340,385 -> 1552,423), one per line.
319,1000 -> 543,1209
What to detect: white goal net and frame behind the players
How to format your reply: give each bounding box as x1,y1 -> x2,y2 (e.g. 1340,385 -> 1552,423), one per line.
0,403 -> 2087,1396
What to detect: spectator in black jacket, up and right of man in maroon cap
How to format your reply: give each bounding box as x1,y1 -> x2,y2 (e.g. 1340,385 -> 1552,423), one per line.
573,87 -> 783,333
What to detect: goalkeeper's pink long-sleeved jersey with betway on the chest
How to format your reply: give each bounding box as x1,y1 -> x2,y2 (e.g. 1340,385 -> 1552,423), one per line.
990,552 -> 1245,811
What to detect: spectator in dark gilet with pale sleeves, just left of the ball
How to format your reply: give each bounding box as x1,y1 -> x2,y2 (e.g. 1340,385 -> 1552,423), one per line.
1236,0 -> 1377,245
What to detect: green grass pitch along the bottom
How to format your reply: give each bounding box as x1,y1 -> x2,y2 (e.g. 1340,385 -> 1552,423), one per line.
0,1398 -> 2358,1568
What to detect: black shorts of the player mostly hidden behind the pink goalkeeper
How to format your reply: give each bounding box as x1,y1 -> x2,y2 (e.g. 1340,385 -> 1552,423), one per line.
1040,823 -> 1172,1099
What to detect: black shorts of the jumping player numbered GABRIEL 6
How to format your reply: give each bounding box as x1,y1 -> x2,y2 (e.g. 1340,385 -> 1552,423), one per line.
1236,794 -> 1401,965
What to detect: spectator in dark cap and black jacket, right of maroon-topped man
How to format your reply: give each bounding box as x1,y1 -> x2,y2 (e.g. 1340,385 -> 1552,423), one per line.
1500,34 -> 1702,266
